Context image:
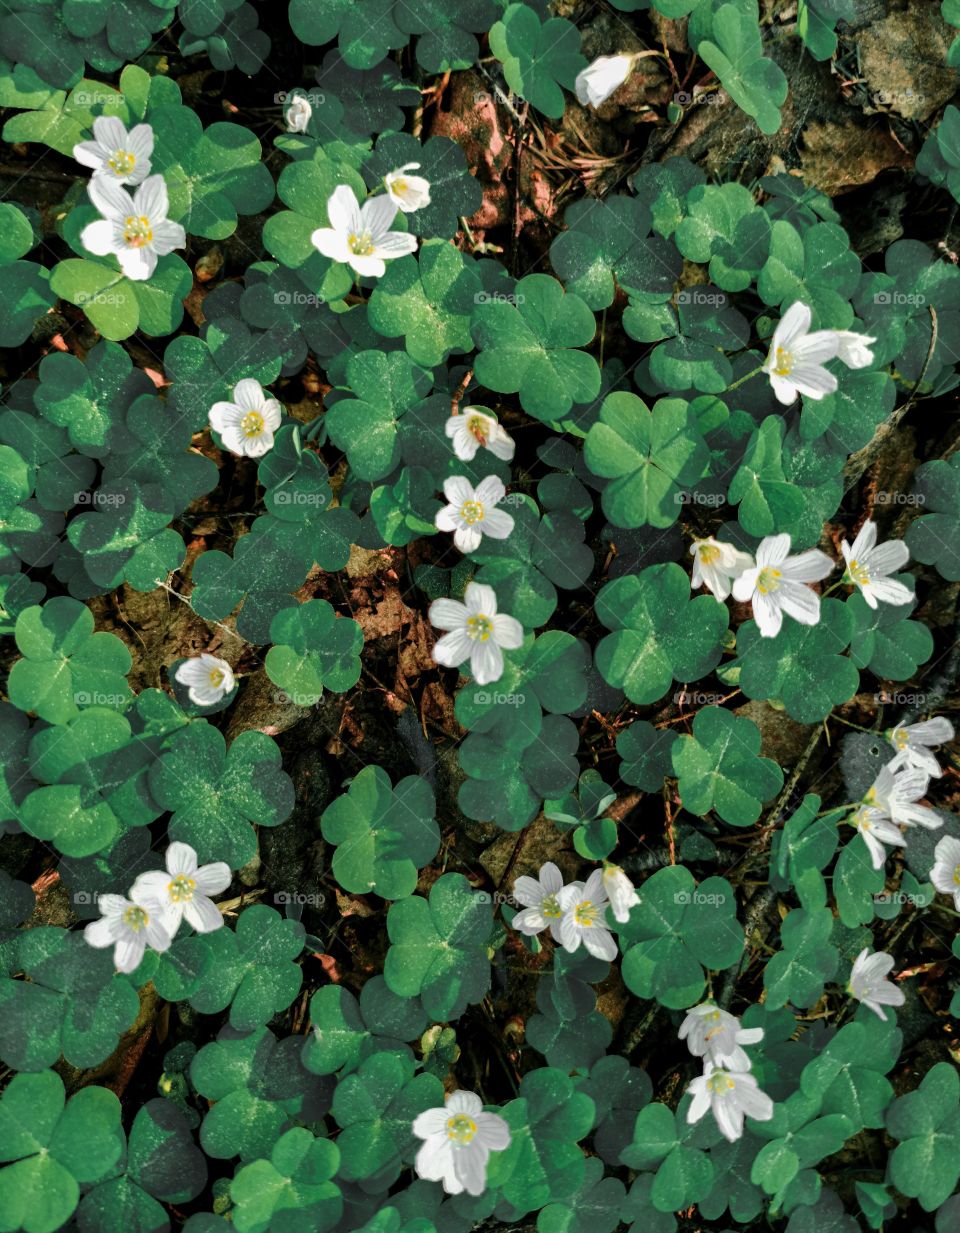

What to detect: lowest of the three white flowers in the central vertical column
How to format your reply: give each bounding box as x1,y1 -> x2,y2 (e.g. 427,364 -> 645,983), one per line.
429,582 -> 524,686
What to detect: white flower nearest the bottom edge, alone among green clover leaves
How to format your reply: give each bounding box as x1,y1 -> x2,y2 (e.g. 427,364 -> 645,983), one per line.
413,1091 -> 510,1195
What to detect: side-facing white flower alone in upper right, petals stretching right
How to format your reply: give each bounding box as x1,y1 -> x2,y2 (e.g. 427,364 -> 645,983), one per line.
763,301 -> 876,407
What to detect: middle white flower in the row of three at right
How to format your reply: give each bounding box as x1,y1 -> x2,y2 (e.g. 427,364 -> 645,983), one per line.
733,533 -> 833,637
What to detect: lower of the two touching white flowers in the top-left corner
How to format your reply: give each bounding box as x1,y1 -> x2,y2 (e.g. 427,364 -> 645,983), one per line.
80,175 -> 186,282
